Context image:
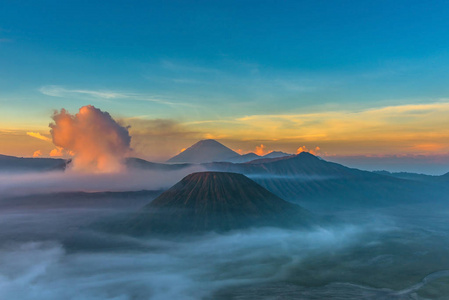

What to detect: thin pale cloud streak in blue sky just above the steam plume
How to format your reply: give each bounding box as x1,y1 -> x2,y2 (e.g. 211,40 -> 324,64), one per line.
39,85 -> 191,106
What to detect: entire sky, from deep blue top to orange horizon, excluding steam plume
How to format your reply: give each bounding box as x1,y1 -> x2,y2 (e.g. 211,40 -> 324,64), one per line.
0,0 -> 449,172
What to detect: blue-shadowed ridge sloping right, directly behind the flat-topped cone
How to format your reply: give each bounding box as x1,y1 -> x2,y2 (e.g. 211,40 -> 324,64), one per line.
127,152 -> 449,211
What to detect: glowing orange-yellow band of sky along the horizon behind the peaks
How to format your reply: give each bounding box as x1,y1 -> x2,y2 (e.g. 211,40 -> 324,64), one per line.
0,102 -> 449,161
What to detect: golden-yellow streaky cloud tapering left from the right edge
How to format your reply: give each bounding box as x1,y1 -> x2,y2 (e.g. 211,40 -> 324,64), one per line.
231,102 -> 449,139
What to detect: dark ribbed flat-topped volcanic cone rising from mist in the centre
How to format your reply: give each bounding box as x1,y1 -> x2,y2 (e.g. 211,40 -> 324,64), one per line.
119,172 -> 316,235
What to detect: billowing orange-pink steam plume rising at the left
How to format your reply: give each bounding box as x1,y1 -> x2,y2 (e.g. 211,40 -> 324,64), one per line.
50,105 -> 131,173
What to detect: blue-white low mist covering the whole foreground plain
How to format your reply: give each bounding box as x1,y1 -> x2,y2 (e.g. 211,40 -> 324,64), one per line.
0,191 -> 449,300
